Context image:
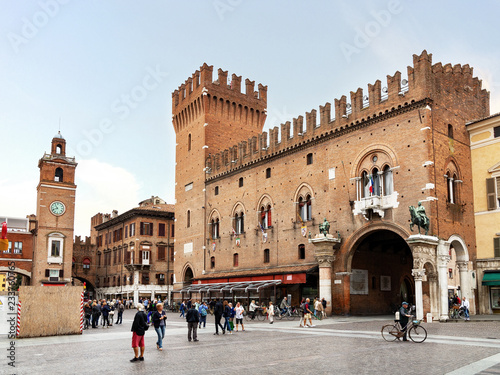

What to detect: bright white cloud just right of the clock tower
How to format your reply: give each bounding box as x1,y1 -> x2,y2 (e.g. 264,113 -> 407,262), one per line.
75,159 -> 141,237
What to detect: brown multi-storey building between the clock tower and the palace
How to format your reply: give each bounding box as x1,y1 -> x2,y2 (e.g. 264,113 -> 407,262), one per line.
91,197 -> 175,303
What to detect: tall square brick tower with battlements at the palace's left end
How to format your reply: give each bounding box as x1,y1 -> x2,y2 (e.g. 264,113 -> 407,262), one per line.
172,63 -> 267,283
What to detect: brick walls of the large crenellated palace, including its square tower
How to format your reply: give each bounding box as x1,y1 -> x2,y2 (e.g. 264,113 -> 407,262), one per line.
173,51 -> 489,313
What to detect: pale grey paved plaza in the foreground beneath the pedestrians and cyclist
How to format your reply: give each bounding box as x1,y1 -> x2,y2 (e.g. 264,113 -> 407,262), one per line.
0,310 -> 500,375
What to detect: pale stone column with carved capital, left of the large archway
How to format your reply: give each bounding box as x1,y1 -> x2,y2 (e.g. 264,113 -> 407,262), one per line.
309,234 -> 340,315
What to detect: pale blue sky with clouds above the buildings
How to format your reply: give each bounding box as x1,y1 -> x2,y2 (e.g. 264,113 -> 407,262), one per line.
0,0 -> 500,235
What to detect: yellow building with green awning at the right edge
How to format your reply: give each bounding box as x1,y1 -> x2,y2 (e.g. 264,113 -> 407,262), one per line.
467,113 -> 500,314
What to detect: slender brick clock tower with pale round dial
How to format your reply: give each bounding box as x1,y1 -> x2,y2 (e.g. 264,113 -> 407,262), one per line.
31,132 -> 77,285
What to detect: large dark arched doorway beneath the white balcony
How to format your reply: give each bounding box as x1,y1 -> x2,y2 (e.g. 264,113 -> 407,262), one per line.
350,229 -> 415,315
